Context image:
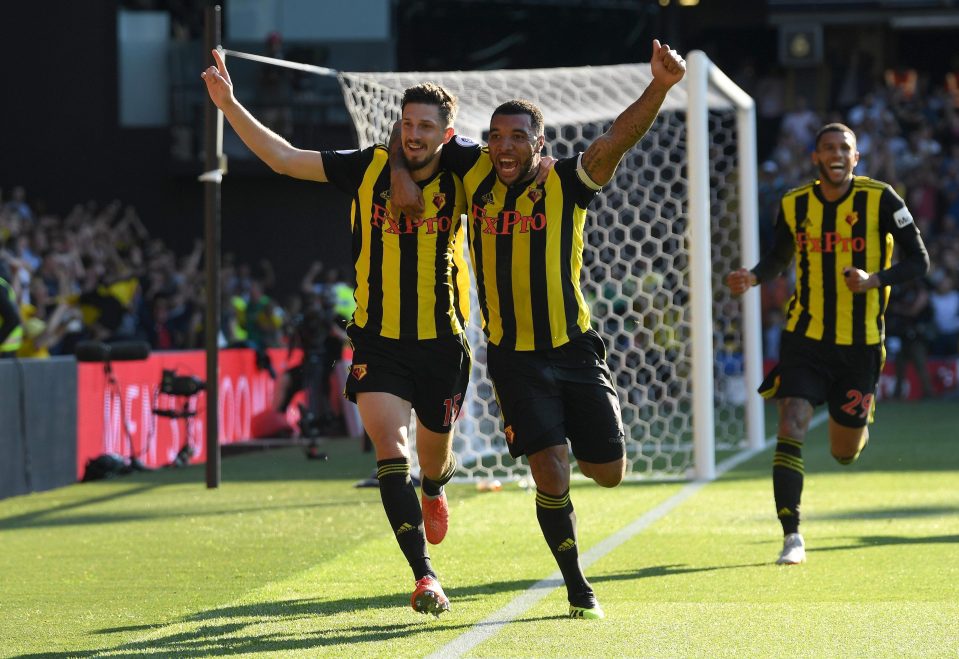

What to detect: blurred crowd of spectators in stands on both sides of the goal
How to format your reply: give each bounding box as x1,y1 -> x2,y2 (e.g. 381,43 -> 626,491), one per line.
0,63 -> 959,408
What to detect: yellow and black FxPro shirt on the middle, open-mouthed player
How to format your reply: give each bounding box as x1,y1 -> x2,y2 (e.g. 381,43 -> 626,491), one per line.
443,137 -> 601,350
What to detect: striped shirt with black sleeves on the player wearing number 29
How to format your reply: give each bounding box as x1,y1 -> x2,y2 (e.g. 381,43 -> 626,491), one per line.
753,176 -> 929,345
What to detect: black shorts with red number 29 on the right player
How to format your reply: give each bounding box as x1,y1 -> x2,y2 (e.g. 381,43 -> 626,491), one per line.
759,332 -> 884,428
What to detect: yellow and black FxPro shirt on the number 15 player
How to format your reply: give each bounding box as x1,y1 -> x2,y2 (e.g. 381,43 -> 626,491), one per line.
323,145 -> 469,339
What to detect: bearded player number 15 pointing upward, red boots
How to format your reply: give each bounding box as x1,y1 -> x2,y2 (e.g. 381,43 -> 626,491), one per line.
202,51 -> 471,615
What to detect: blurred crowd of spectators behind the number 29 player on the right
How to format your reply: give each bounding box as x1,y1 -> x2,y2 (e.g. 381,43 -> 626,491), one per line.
754,66 -> 959,396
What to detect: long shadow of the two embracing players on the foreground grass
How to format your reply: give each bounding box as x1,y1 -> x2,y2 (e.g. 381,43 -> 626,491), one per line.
16,580 -> 566,659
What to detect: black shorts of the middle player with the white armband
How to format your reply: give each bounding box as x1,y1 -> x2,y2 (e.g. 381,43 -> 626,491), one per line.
486,330 -> 626,464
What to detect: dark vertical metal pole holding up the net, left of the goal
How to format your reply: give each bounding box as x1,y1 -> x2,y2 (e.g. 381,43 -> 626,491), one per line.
200,5 -> 222,488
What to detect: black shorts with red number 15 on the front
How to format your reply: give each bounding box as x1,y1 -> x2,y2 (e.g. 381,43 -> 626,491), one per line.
343,325 -> 472,433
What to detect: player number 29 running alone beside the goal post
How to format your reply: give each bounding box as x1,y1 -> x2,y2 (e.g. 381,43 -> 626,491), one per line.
727,123 -> 929,564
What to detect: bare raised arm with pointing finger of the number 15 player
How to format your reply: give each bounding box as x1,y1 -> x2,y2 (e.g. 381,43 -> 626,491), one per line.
200,50 -> 327,183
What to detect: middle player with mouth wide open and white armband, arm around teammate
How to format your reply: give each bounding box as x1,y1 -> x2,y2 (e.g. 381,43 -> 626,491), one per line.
391,40 -> 686,618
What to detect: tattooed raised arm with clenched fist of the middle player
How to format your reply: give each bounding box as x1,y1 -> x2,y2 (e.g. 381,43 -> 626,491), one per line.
583,39 -> 686,185
